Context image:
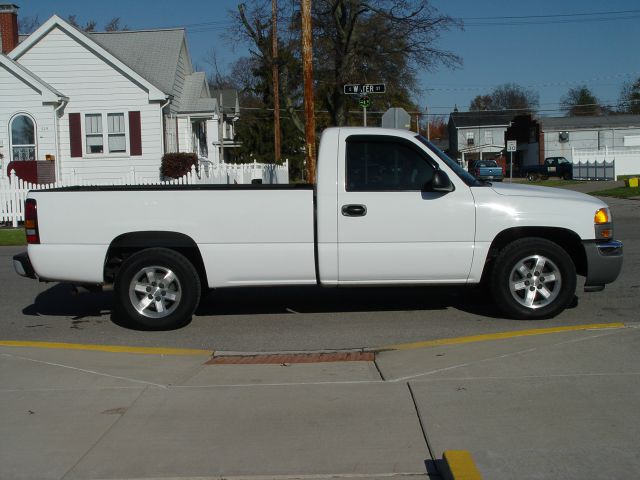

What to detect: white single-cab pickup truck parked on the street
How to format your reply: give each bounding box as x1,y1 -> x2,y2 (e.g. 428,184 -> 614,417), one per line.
14,128 -> 622,329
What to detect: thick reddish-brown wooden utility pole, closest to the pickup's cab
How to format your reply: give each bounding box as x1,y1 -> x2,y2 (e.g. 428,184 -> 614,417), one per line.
300,0 -> 316,183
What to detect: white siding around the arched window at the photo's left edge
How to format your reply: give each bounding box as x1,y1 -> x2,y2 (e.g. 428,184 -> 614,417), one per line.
0,62 -> 57,176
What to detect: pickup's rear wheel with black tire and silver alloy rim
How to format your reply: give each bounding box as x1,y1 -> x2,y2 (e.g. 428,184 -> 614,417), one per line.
114,248 -> 200,330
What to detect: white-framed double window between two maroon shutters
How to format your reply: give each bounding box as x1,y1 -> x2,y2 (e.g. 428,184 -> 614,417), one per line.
84,113 -> 127,154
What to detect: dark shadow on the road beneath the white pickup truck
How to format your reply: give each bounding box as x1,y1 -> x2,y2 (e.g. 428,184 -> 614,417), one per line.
22,284 -> 510,327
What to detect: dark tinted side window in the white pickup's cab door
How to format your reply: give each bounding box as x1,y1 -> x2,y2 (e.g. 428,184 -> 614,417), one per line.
346,136 -> 435,192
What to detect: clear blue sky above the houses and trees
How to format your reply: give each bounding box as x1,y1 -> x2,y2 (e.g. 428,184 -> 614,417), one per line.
13,0 -> 640,116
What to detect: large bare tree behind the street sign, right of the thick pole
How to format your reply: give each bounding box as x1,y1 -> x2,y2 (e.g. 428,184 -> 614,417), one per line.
314,0 -> 462,125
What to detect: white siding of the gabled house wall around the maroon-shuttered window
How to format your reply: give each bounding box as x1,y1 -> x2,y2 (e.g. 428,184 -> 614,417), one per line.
18,28 -> 163,183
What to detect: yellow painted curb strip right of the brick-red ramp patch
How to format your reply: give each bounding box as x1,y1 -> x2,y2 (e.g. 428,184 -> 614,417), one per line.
380,323 -> 626,350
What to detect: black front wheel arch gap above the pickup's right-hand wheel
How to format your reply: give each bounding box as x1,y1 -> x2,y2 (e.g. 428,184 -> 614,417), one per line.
482,227 -> 587,280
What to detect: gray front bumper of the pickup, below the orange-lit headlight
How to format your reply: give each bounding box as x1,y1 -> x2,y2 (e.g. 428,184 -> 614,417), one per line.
582,240 -> 622,290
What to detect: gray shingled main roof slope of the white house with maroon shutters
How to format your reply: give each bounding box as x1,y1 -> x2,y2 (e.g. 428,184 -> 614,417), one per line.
88,28 -> 184,94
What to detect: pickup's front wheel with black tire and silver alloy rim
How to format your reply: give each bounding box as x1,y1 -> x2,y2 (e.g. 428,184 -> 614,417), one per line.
491,237 -> 576,320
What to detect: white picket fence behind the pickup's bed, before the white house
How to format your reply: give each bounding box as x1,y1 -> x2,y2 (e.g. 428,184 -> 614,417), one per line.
0,161 -> 289,227
